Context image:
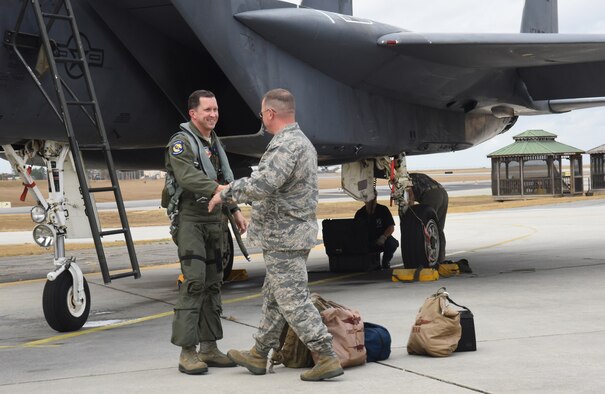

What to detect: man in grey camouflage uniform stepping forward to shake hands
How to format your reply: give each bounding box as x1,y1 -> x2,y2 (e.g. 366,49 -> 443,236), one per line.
209,89 -> 343,380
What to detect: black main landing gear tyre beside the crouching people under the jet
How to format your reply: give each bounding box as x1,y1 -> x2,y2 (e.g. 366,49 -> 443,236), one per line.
400,204 -> 441,268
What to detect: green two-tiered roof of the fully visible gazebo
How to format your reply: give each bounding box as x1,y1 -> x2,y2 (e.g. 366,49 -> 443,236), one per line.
487,130 -> 584,157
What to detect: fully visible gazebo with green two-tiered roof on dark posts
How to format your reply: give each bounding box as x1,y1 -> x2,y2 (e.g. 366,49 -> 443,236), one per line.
487,130 -> 584,200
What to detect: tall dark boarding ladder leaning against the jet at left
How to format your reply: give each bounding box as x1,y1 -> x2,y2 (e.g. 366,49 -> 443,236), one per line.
5,0 -> 141,283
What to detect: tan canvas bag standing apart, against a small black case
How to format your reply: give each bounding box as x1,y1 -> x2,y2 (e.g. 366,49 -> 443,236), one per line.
407,287 -> 462,357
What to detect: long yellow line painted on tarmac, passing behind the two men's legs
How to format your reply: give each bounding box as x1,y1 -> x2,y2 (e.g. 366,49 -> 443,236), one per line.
16,272 -> 364,349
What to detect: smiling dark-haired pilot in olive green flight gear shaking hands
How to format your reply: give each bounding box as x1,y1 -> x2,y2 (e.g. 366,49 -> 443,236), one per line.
163,90 -> 247,374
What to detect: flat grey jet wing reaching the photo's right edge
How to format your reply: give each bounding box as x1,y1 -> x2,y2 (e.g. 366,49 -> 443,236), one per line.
378,32 -> 605,100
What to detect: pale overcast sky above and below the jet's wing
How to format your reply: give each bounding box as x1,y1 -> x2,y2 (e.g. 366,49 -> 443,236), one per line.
0,0 -> 605,172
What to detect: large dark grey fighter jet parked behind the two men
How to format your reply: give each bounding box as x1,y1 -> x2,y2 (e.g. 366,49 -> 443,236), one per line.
0,0 -> 605,330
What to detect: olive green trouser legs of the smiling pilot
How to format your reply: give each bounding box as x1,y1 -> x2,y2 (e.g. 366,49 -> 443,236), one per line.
171,221 -> 224,347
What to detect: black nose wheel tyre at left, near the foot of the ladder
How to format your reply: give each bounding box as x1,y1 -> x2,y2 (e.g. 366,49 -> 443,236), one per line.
42,270 -> 90,332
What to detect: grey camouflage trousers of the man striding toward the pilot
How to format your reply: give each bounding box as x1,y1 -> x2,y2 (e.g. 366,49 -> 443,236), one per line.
254,250 -> 333,354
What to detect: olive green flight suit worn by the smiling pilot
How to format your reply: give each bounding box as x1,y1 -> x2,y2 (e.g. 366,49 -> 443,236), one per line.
165,122 -> 237,347
